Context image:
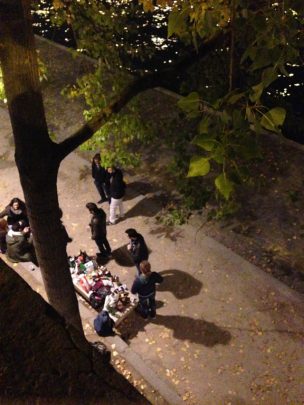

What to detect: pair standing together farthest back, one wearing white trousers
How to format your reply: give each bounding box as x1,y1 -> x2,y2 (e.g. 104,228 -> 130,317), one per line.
92,153 -> 126,225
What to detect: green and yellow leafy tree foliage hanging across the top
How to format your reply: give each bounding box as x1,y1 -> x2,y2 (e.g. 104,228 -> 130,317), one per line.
44,0 -> 304,200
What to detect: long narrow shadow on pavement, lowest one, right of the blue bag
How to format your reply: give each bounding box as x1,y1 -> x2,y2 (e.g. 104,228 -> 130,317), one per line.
119,313 -> 232,347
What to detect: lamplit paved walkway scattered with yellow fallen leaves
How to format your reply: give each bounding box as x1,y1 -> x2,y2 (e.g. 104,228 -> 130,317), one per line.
0,104 -> 304,405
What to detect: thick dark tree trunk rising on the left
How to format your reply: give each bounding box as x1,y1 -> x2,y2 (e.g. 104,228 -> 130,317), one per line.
0,0 -> 82,331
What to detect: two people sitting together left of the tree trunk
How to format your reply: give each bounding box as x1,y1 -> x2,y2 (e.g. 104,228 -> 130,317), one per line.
0,197 -> 38,265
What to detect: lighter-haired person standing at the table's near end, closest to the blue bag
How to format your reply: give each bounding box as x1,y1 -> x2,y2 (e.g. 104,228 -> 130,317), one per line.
131,260 -> 163,319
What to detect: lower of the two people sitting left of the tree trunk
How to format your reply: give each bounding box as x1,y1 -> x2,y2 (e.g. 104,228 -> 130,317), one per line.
6,221 -> 38,266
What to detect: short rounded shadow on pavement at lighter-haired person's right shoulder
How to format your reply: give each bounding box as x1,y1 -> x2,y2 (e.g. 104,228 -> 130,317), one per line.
157,269 -> 203,300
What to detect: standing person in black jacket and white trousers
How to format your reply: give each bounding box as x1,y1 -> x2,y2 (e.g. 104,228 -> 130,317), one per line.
107,166 -> 126,225
